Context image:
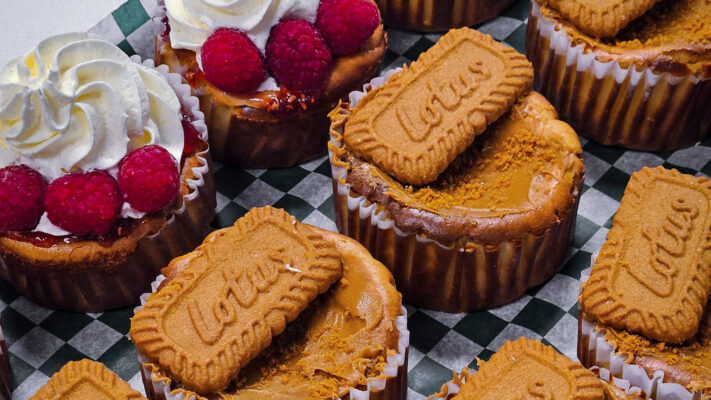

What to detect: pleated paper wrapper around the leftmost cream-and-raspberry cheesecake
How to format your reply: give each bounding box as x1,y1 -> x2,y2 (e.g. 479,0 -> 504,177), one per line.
0,56 -> 216,312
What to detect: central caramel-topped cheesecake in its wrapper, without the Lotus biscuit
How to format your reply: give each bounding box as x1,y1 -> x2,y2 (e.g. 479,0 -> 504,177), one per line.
329,85 -> 584,312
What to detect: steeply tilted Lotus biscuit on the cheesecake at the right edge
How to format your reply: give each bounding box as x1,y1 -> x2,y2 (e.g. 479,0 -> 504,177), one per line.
581,167 -> 711,343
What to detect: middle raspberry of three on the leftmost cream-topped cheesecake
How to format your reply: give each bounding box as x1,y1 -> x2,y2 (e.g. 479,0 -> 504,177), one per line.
44,171 -> 123,236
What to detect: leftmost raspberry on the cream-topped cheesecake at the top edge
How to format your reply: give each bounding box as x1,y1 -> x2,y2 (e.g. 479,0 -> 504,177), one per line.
201,28 -> 266,93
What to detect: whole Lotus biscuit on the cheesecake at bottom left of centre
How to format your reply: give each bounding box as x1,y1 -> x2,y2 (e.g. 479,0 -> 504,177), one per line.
131,207 -> 342,393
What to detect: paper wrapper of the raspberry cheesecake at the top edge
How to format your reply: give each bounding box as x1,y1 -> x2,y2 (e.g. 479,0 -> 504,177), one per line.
154,7 -> 380,168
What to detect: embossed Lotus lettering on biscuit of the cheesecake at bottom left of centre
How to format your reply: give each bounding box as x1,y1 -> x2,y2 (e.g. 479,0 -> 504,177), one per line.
187,247 -> 298,345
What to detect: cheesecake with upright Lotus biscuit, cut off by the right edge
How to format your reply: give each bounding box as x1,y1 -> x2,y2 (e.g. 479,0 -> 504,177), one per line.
578,167 -> 711,400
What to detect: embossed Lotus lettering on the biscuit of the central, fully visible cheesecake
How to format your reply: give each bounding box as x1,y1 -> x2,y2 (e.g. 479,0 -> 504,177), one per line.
395,61 -> 491,142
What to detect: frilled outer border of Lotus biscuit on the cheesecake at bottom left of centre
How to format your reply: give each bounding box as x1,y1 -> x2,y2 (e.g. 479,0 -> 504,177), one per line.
130,207 -> 342,393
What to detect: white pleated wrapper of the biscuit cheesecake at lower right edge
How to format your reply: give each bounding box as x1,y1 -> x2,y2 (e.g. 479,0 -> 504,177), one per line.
578,268 -> 703,400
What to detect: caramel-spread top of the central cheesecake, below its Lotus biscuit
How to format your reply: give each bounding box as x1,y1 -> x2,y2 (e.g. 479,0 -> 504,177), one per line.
334,92 -> 584,245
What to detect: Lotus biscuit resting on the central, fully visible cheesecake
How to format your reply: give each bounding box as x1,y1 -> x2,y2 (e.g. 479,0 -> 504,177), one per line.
344,28 -> 533,185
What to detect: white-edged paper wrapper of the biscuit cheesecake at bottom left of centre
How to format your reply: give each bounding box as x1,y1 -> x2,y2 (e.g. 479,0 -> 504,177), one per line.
136,275 -> 410,400
